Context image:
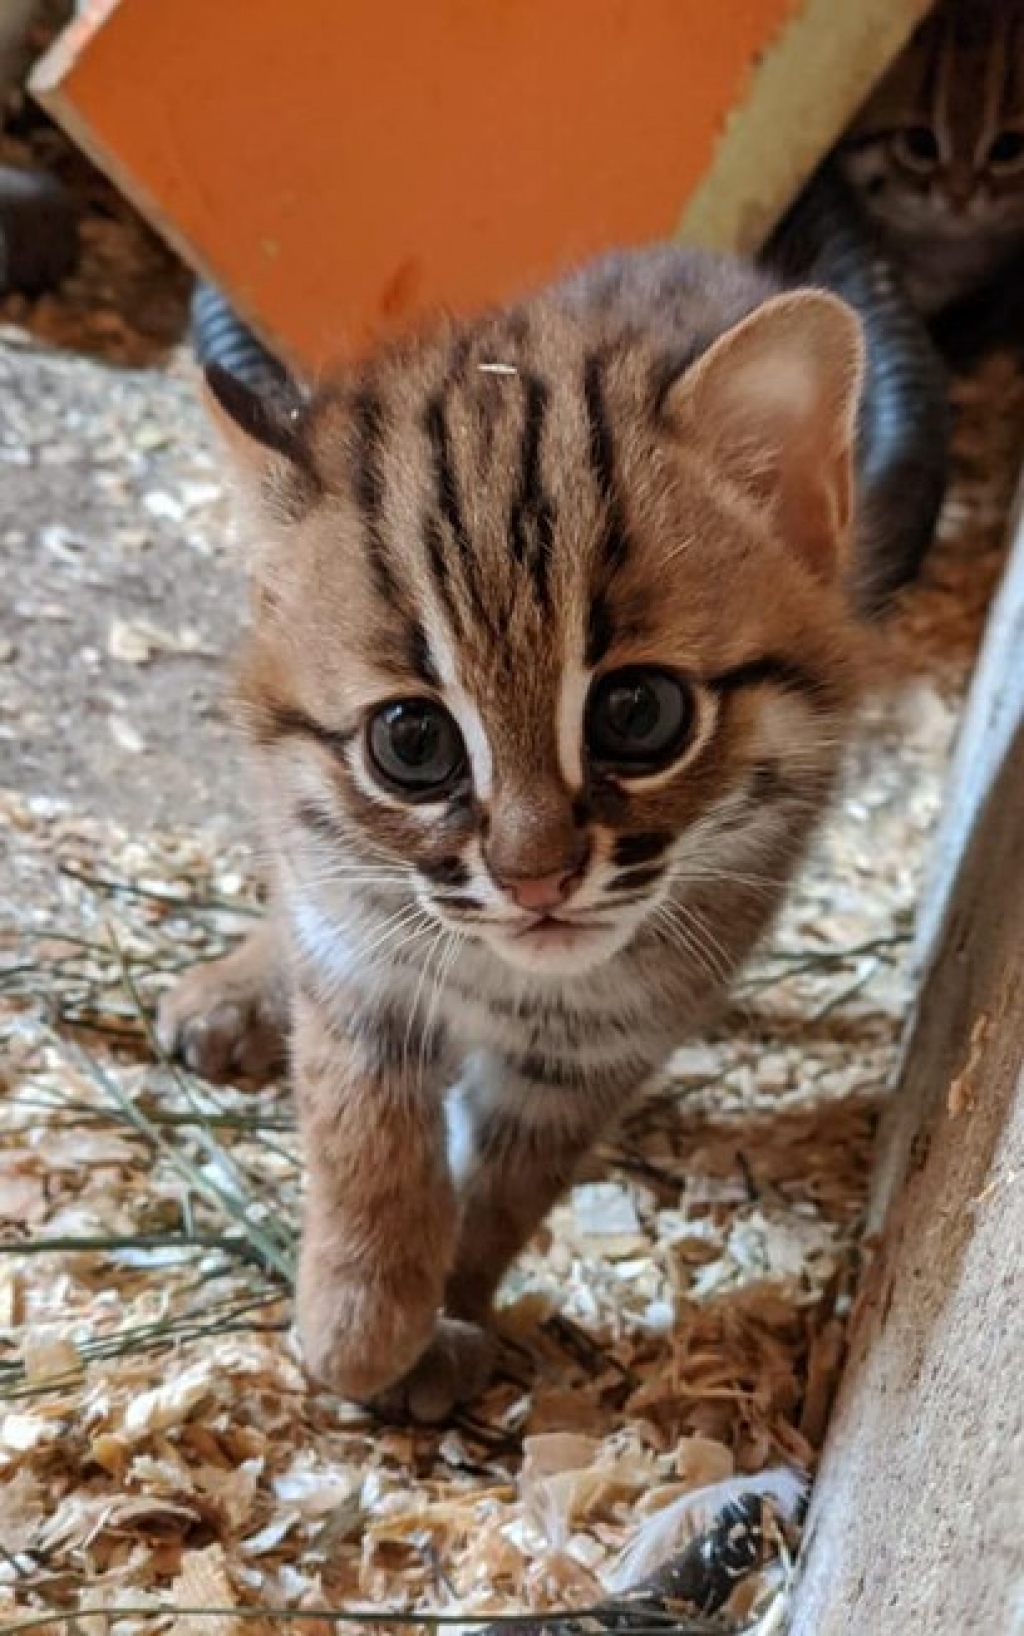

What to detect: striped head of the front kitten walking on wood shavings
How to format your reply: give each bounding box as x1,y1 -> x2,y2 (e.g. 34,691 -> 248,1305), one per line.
213,266 -> 860,977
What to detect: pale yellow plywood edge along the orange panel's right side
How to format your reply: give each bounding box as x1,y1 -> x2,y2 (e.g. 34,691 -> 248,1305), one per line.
677,0 -> 931,254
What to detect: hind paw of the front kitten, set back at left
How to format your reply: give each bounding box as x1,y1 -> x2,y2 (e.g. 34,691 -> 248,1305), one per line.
157,918 -> 290,1085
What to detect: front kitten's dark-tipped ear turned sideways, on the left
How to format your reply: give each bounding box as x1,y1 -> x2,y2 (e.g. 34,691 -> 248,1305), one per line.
196,363 -> 319,520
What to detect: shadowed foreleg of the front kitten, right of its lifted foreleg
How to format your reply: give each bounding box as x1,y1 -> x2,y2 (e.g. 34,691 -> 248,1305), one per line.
445,1062 -> 643,1325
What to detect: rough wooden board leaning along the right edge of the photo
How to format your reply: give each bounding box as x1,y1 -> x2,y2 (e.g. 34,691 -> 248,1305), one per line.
790,487 -> 1024,1636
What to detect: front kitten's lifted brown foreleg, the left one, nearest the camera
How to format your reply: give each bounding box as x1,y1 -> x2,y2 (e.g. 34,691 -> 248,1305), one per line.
293,988 -> 476,1417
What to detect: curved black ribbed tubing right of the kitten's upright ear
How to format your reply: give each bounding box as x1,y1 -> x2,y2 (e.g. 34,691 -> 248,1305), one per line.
762,167 -> 950,614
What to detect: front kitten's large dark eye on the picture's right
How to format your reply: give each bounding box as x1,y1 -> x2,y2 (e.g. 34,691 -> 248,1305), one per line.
586,666 -> 694,775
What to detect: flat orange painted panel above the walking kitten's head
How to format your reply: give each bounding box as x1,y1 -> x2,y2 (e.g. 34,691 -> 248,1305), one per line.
41,0 -> 798,366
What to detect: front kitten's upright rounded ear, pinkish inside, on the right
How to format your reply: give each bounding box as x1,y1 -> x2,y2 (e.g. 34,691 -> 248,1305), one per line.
671,290 -> 864,581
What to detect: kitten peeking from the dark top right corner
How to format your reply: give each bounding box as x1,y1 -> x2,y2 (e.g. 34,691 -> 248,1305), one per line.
838,0 -> 1024,316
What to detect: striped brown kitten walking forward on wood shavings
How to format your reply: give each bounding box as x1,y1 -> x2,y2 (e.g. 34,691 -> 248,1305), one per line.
160,250 -> 862,1420
